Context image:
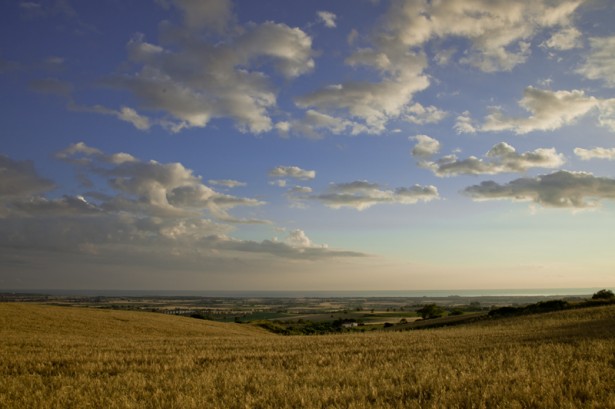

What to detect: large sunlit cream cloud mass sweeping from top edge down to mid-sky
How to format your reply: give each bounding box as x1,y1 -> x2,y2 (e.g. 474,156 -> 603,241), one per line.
295,0 -> 581,134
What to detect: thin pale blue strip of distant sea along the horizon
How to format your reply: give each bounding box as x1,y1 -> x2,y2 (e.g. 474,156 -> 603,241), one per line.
0,288 -> 602,298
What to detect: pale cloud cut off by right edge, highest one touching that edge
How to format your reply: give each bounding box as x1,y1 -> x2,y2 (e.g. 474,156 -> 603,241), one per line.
577,36 -> 615,87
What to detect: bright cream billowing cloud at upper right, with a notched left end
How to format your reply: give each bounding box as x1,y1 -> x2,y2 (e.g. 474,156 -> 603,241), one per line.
480,87 -> 599,134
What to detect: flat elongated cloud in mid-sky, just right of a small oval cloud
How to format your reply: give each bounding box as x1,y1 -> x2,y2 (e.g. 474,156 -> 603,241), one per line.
309,181 -> 439,210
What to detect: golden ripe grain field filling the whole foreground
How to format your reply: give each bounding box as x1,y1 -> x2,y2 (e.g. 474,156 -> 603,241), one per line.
0,303 -> 615,409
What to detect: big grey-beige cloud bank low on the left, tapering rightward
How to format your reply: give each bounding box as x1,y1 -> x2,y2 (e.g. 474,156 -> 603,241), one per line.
0,148 -> 364,261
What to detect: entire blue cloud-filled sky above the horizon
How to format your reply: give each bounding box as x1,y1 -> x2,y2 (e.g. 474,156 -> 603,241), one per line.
0,0 -> 615,291
